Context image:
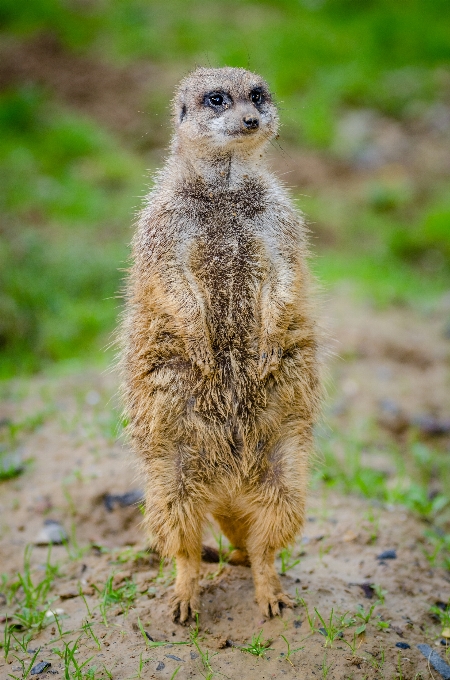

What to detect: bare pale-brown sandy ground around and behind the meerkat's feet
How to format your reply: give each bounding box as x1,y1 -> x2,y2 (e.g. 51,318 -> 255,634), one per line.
0,290 -> 450,680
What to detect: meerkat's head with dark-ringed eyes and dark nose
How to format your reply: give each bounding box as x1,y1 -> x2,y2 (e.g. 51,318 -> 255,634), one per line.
174,68 -> 278,155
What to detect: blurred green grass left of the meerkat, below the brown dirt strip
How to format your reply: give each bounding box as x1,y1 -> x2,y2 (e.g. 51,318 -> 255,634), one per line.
0,88 -> 143,377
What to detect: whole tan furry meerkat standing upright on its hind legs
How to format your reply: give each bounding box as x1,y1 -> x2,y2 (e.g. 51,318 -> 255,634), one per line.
121,68 -> 320,623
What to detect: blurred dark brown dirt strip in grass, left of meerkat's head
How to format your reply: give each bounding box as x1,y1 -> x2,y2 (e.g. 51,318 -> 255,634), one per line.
0,36 -> 174,148
